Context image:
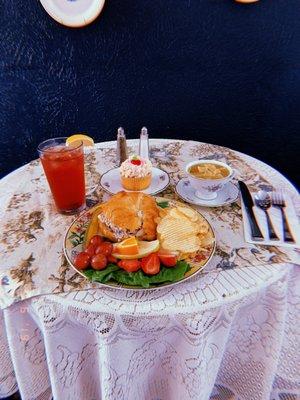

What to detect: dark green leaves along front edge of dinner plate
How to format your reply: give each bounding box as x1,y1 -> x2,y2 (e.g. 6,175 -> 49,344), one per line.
83,261 -> 190,288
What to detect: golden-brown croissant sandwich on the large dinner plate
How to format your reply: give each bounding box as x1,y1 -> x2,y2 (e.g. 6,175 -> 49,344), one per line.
98,192 -> 159,242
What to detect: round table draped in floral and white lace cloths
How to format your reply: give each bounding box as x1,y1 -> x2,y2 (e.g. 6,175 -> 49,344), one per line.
0,139 -> 300,400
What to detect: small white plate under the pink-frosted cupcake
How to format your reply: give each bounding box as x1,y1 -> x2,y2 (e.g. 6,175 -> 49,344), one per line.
100,168 -> 170,195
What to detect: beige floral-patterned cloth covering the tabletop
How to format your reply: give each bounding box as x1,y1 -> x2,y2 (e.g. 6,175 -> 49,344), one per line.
0,139 -> 300,308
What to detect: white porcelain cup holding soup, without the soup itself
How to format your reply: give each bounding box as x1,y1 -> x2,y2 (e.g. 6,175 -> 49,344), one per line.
185,160 -> 234,200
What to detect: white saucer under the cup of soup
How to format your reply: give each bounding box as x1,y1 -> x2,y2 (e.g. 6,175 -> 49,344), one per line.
175,178 -> 239,207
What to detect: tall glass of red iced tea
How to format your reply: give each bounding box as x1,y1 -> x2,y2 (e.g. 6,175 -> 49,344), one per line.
38,137 -> 85,214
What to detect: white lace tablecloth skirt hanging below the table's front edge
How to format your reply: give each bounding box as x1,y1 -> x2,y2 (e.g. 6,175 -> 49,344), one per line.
0,265 -> 300,400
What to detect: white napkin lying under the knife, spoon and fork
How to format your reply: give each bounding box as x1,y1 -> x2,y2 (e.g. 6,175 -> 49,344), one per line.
241,193 -> 300,248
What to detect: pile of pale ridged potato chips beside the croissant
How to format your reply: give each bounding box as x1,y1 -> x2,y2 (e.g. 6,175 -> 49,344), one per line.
157,206 -> 213,259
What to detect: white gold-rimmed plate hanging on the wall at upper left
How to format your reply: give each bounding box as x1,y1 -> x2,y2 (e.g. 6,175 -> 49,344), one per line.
40,0 -> 105,28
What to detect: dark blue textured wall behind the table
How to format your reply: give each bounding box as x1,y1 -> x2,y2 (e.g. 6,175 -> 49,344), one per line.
0,0 -> 300,183
